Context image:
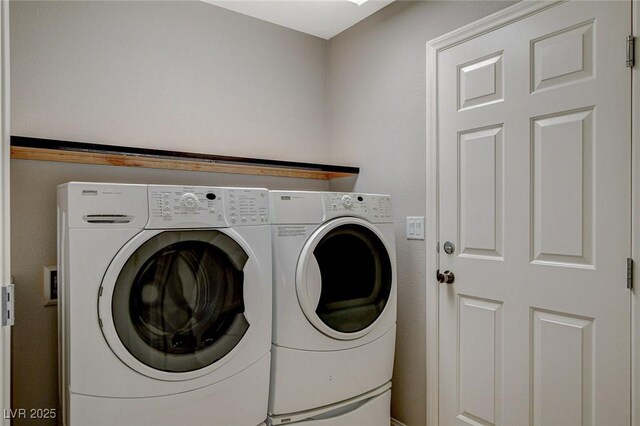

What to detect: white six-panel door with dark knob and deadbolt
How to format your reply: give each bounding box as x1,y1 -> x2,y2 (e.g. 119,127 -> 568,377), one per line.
437,1 -> 631,426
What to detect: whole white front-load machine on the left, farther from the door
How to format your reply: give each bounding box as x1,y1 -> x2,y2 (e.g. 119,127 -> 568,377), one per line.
58,182 -> 271,426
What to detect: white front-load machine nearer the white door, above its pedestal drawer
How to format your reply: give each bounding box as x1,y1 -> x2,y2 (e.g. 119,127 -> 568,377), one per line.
269,191 -> 397,425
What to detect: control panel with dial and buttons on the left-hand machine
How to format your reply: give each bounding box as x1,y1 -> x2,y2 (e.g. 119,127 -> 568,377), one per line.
147,185 -> 269,229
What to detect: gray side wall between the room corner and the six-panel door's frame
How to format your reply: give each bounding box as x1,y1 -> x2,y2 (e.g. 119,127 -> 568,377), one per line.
328,1 -> 511,426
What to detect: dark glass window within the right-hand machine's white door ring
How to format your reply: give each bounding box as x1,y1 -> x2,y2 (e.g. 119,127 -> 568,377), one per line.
313,224 -> 391,333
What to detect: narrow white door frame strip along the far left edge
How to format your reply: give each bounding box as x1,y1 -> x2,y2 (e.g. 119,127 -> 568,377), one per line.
0,0 -> 11,426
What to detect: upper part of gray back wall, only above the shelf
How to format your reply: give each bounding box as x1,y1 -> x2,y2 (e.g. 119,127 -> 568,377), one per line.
10,1 -> 327,162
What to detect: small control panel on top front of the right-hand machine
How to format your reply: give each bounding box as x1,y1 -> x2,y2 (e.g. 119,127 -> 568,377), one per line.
322,192 -> 391,222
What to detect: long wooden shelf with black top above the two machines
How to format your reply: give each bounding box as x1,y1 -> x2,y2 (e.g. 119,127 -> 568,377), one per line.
11,136 -> 360,180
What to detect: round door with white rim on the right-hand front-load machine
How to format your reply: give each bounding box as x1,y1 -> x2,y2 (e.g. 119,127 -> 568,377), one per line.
296,217 -> 392,340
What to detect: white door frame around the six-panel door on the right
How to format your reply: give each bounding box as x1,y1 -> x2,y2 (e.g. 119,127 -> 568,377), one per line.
426,0 -> 640,426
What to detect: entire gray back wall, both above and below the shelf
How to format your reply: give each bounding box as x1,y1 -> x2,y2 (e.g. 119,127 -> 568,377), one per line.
10,1 -> 328,425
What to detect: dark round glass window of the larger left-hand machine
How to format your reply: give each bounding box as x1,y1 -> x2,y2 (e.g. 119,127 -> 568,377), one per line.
112,230 -> 249,372
